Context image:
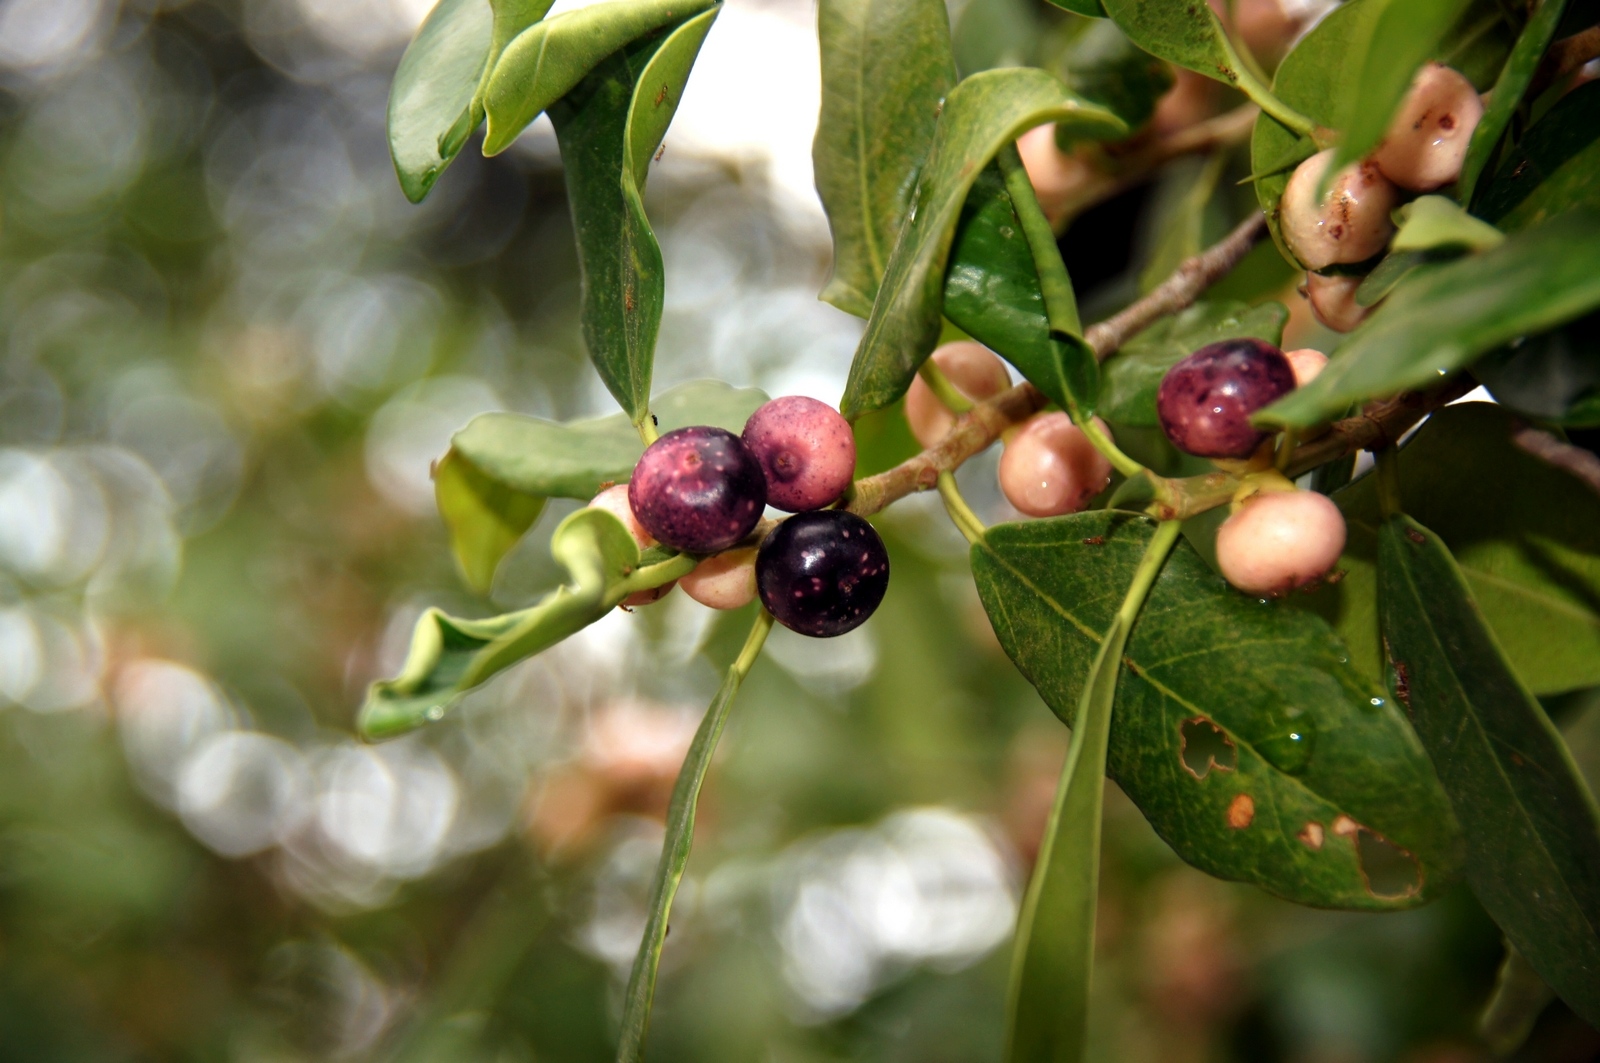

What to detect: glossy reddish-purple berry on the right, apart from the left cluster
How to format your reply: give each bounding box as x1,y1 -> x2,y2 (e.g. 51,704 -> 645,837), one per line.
1155,339 -> 1294,458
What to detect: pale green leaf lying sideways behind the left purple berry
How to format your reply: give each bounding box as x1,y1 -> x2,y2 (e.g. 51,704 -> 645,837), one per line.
450,381 -> 766,499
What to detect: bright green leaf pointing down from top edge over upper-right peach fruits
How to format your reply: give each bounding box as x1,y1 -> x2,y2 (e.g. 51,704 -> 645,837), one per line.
1330,0 -> 1470,173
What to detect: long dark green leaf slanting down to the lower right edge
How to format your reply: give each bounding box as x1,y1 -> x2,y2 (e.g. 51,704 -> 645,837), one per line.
1378,515 -> 1600,1023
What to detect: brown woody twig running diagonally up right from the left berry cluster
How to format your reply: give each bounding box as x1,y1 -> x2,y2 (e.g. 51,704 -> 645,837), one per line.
850,215 -> 1266,517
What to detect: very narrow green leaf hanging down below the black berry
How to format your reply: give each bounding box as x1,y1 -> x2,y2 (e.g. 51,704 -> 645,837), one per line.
616,608 -> 773,1063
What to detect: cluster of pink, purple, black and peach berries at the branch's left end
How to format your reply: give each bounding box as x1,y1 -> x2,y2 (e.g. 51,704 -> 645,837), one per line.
590,395 -> 890,637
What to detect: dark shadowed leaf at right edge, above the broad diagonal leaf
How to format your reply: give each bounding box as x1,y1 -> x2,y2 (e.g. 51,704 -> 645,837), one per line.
1472,82 -> 1600,231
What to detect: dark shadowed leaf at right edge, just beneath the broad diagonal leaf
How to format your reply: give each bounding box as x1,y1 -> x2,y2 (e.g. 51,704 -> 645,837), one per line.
1472,314 -> 1600,427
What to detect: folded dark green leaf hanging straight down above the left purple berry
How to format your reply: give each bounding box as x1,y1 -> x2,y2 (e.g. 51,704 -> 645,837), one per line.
550,11 -> 718,424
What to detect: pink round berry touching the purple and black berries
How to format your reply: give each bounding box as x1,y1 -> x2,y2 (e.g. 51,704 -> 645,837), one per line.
744,395 -> 856,512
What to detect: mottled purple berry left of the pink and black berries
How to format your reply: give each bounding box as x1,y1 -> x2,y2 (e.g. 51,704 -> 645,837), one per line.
627,427 -> 766,554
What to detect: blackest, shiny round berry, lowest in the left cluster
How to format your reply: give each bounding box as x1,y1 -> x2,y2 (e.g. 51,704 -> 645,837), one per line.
755,509 -> 890,639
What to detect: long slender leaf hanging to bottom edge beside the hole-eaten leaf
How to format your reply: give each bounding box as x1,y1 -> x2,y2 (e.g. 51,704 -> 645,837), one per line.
1006,523 -> 1178,1063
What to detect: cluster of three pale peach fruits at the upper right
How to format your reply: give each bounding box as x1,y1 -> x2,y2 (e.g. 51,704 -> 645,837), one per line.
1278,62 -> 1483,331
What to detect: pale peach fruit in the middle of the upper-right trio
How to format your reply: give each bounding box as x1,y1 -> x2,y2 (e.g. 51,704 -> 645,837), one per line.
1278,147 -> 1400,269
